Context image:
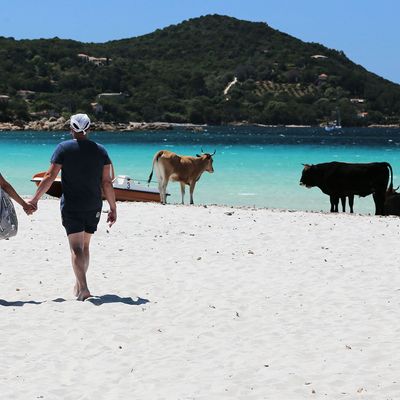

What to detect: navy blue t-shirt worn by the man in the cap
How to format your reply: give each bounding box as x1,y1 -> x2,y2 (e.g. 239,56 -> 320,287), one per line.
51,139 -> 111,211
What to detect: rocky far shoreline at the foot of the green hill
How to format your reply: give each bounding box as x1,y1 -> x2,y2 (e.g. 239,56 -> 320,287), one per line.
0,117 -> 400,132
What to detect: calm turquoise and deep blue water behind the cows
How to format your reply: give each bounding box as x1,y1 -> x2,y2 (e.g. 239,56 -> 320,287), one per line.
0,127 -> 400,213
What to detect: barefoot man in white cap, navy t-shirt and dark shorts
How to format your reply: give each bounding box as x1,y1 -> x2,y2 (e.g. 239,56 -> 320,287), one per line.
28,114 -> 117,301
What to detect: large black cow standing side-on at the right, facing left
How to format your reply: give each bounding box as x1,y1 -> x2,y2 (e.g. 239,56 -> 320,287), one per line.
300,161 -> 393,215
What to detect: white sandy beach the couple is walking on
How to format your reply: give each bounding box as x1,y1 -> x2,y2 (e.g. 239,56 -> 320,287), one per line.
0,200 -> 400,400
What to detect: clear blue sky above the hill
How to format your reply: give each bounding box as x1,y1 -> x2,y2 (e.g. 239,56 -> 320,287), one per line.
0,0 -> 400,83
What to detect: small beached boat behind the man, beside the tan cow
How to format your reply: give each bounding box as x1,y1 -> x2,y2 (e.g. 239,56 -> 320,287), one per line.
31,172 -> 166,203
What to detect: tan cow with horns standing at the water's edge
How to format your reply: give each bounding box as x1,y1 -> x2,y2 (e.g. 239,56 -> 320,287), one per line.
147,150 -> 215,204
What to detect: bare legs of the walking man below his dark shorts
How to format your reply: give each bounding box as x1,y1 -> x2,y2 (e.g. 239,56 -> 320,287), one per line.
68,232 -> 91,301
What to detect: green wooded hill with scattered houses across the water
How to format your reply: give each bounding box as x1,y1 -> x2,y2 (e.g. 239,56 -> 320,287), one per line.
0,15 -> 400,126
